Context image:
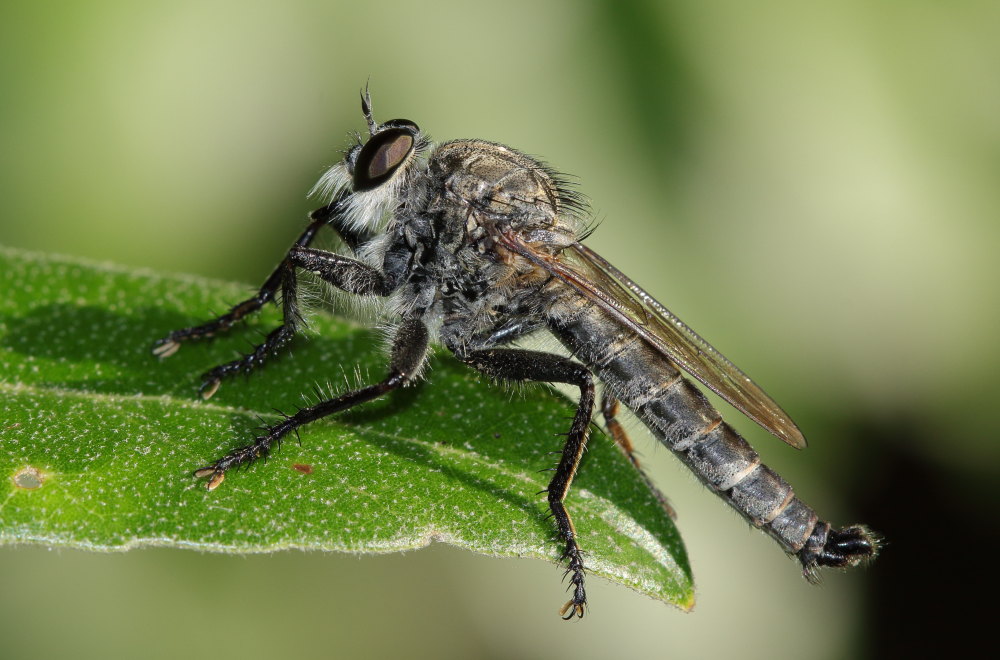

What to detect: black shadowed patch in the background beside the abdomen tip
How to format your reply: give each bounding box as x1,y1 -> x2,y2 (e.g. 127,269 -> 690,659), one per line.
851,420 -> 1000,658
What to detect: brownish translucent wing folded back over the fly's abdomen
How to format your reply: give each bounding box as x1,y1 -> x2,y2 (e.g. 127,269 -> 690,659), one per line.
501,234 -> 806,449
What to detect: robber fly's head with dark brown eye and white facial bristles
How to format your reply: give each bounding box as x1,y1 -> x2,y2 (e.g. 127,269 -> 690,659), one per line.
309,90 -> 430,232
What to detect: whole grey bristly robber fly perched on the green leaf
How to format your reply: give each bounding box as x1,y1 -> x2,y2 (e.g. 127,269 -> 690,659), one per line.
153,91 -> 879,619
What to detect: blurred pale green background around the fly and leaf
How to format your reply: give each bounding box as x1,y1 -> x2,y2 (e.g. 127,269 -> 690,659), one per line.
0,0 -> 1000,660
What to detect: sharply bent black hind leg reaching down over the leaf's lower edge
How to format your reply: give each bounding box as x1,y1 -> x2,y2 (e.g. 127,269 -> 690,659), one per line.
459,348 -> 594,619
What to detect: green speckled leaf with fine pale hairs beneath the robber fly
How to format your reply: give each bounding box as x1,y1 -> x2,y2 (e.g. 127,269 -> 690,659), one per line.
0,249 -> 693,609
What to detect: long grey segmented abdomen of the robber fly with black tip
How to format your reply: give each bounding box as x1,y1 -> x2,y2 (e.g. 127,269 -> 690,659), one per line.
551,303 -> 877,577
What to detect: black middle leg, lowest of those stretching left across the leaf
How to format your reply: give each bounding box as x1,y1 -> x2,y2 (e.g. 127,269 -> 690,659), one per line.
194,319 -> 428,490
